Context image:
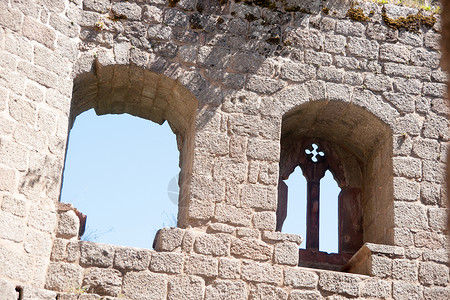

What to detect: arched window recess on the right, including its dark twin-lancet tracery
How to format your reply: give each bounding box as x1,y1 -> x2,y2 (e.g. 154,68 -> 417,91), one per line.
276,101 -> 393,270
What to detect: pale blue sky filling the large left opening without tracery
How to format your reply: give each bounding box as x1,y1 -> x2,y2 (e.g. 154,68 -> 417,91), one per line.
61,109 -> 180,248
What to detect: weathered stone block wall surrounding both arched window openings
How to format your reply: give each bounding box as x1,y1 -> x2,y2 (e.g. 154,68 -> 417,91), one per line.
0,0 -> 449,299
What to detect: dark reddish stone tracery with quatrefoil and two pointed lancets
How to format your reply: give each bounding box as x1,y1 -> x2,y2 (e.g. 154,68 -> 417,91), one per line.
276,139 -> 363,270
